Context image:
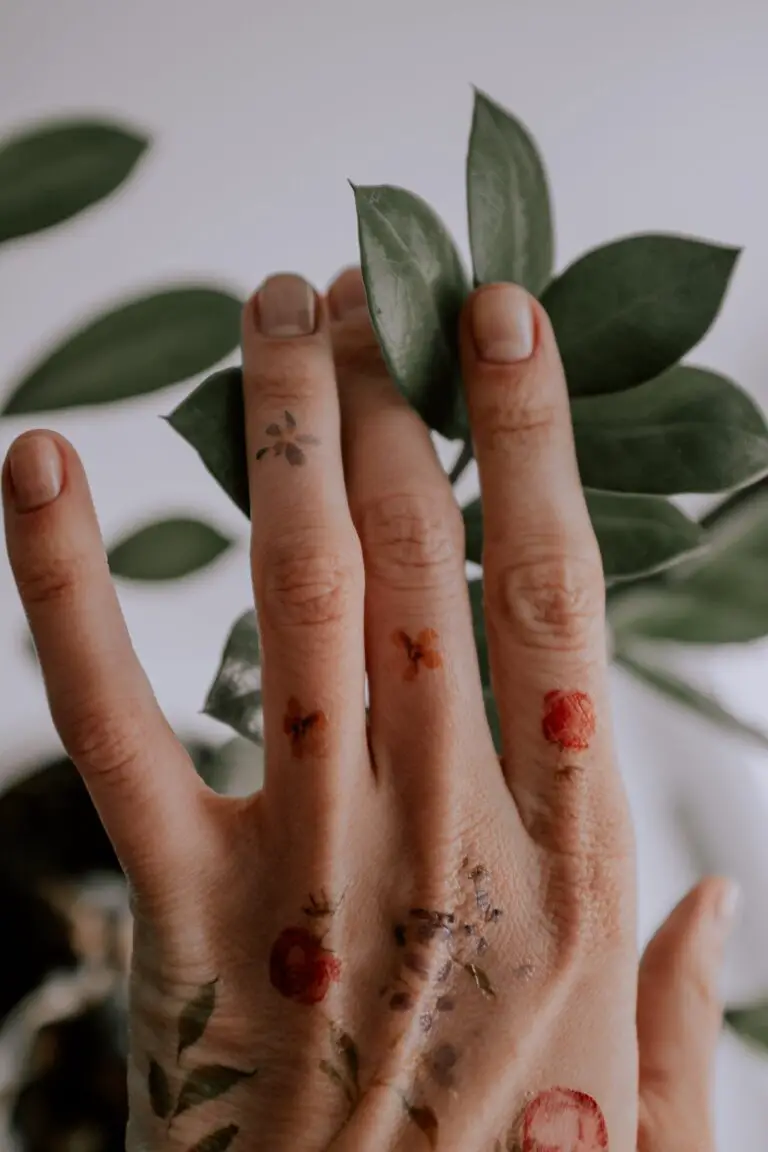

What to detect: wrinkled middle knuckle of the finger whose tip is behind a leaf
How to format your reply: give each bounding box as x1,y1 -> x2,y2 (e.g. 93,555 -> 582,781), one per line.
359,493 -> 464,590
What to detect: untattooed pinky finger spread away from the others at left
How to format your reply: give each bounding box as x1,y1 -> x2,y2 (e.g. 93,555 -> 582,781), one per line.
2,431 -> 198,887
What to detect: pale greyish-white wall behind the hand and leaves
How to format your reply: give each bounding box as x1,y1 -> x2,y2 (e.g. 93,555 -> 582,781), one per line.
0,0 -> 768,1150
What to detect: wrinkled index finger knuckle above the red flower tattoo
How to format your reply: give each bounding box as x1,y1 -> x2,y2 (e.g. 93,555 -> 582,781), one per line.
489,548 -> 604,652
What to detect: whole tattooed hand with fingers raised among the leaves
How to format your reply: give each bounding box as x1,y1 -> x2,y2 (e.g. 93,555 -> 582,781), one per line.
2,270 -> 732,1152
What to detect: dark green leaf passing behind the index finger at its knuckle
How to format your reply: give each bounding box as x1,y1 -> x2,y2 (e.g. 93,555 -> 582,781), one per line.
464,490 -> 701,581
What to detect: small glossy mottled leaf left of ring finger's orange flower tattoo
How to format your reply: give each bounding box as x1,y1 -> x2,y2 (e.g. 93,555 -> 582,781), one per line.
203,608 -> 264,744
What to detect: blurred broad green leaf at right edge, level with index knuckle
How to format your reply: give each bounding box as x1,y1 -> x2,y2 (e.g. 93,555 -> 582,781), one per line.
610,492 -> 768,644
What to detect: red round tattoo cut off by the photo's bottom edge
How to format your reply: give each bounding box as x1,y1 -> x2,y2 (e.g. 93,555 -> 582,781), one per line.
523,1087 -> 608,1152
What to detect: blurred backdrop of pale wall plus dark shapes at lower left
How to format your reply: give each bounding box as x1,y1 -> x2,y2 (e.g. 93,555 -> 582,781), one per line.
0,0 -> 768,1152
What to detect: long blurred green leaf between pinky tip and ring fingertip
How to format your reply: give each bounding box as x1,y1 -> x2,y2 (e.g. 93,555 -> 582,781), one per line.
3,286 -> 242,416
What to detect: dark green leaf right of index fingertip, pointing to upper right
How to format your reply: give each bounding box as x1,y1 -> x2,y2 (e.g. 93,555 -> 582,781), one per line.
541,235 -> 739,396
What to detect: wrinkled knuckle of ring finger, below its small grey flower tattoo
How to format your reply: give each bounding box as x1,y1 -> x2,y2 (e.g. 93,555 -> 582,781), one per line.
261,530 -> 362,628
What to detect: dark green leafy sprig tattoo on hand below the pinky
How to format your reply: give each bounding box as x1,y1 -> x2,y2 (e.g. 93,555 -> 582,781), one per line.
147,979 -> 257,1152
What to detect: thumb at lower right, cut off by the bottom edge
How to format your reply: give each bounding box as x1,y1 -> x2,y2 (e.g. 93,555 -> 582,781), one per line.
638,878 -> 739,1152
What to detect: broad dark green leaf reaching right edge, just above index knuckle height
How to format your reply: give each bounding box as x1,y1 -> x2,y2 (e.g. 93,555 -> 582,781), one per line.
571,365 -> 768,495
